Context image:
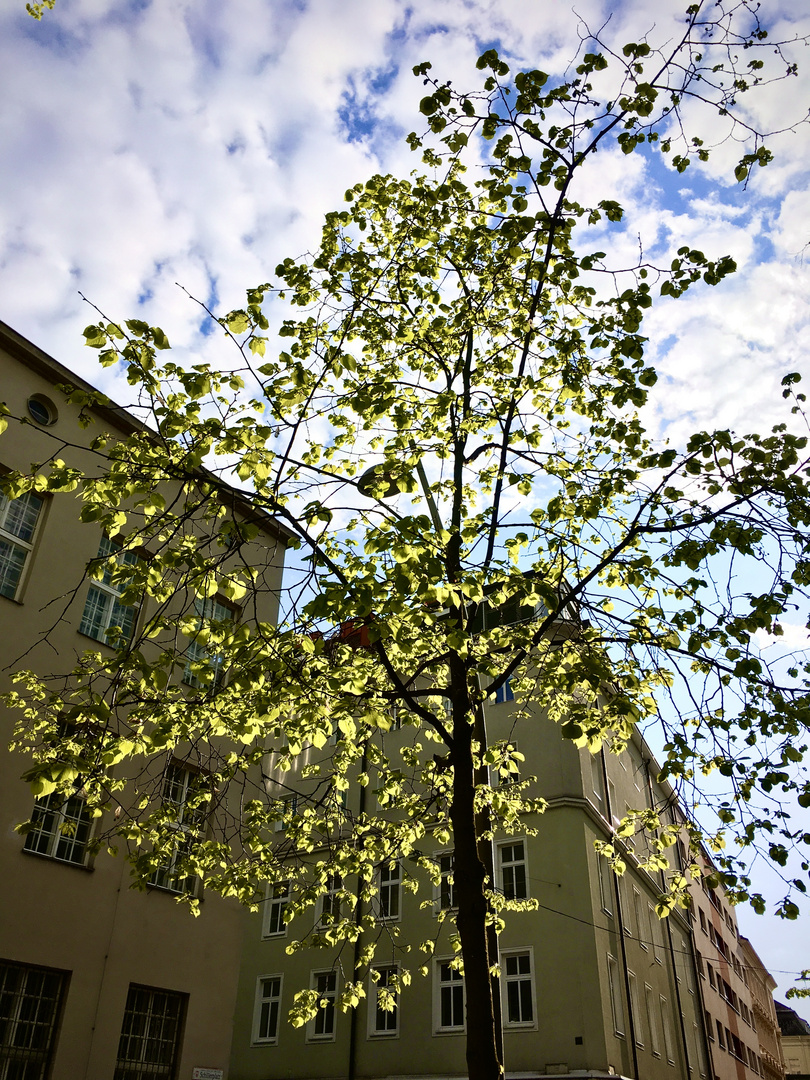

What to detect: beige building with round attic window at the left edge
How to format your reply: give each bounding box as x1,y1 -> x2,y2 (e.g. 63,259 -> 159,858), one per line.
0,324 -> 286,1080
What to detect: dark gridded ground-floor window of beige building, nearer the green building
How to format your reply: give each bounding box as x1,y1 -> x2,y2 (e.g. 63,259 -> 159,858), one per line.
113,984 -> 186,1080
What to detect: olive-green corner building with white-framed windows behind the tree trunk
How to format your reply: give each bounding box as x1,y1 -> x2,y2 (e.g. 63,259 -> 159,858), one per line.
229,673 -> 719,1080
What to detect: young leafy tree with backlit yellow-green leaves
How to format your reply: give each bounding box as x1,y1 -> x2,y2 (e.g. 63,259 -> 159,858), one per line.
2,2 -> 810,1078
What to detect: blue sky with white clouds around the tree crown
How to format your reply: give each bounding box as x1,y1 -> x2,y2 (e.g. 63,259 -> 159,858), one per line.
0,0 -> 810,993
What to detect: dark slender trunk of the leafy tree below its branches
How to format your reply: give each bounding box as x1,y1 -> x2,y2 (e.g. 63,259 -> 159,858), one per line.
450,711 -> 502,1080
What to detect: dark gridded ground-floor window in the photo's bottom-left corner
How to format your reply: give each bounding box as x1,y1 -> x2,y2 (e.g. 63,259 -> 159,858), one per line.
0,961 -> 66,1080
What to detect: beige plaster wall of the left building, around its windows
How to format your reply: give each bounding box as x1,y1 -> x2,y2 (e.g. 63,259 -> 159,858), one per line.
0,324 -> 284,1080
